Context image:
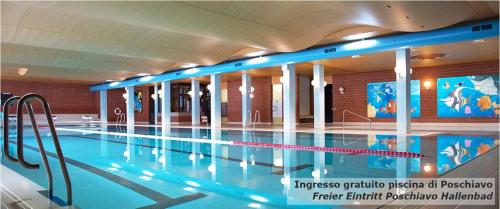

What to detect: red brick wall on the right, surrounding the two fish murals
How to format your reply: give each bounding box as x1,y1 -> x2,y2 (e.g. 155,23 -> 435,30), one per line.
332,60 -> 498,123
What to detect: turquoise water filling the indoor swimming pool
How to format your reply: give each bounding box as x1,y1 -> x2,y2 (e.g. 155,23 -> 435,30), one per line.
2,126 -> 498,209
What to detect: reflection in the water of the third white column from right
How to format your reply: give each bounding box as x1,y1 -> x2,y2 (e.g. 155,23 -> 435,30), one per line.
281,131 -> 297,194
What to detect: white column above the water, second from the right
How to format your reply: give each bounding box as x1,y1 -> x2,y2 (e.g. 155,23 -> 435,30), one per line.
313,64 -> 325,128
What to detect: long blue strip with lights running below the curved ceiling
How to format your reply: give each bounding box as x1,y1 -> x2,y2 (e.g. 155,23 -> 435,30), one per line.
90,19 -> 499,91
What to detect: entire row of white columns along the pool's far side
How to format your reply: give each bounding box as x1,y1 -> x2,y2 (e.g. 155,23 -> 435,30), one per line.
100,48 -> 411,134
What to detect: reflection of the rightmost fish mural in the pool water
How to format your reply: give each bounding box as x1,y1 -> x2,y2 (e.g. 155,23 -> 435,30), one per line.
437,136 -> 498,174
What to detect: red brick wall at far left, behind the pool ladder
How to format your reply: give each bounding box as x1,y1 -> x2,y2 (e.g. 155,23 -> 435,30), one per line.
1,80 -> 99,114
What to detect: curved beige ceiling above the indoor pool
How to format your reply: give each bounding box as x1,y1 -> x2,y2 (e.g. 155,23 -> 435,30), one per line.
1,1 -> 498,83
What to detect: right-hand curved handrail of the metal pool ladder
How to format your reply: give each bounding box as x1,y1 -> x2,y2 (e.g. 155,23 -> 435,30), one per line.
17,93 -> 73,205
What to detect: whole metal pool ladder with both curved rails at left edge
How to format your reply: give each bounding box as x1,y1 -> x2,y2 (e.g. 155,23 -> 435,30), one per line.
3,93 -> 73,206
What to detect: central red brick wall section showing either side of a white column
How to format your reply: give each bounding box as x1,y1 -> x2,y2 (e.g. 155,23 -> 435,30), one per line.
227,77 -> 273,122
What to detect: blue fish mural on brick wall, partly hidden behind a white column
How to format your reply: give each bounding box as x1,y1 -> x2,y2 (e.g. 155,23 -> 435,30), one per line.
367,80 -> 420,118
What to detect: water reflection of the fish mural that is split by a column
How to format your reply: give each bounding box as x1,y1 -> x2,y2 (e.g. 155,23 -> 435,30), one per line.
368,135 -> 420,173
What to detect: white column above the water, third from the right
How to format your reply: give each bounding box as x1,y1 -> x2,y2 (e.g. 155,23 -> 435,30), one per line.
281,64 -> 297,130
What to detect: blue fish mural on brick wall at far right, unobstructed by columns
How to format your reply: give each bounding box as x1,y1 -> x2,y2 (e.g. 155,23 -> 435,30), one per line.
437,75 -> 500,118
